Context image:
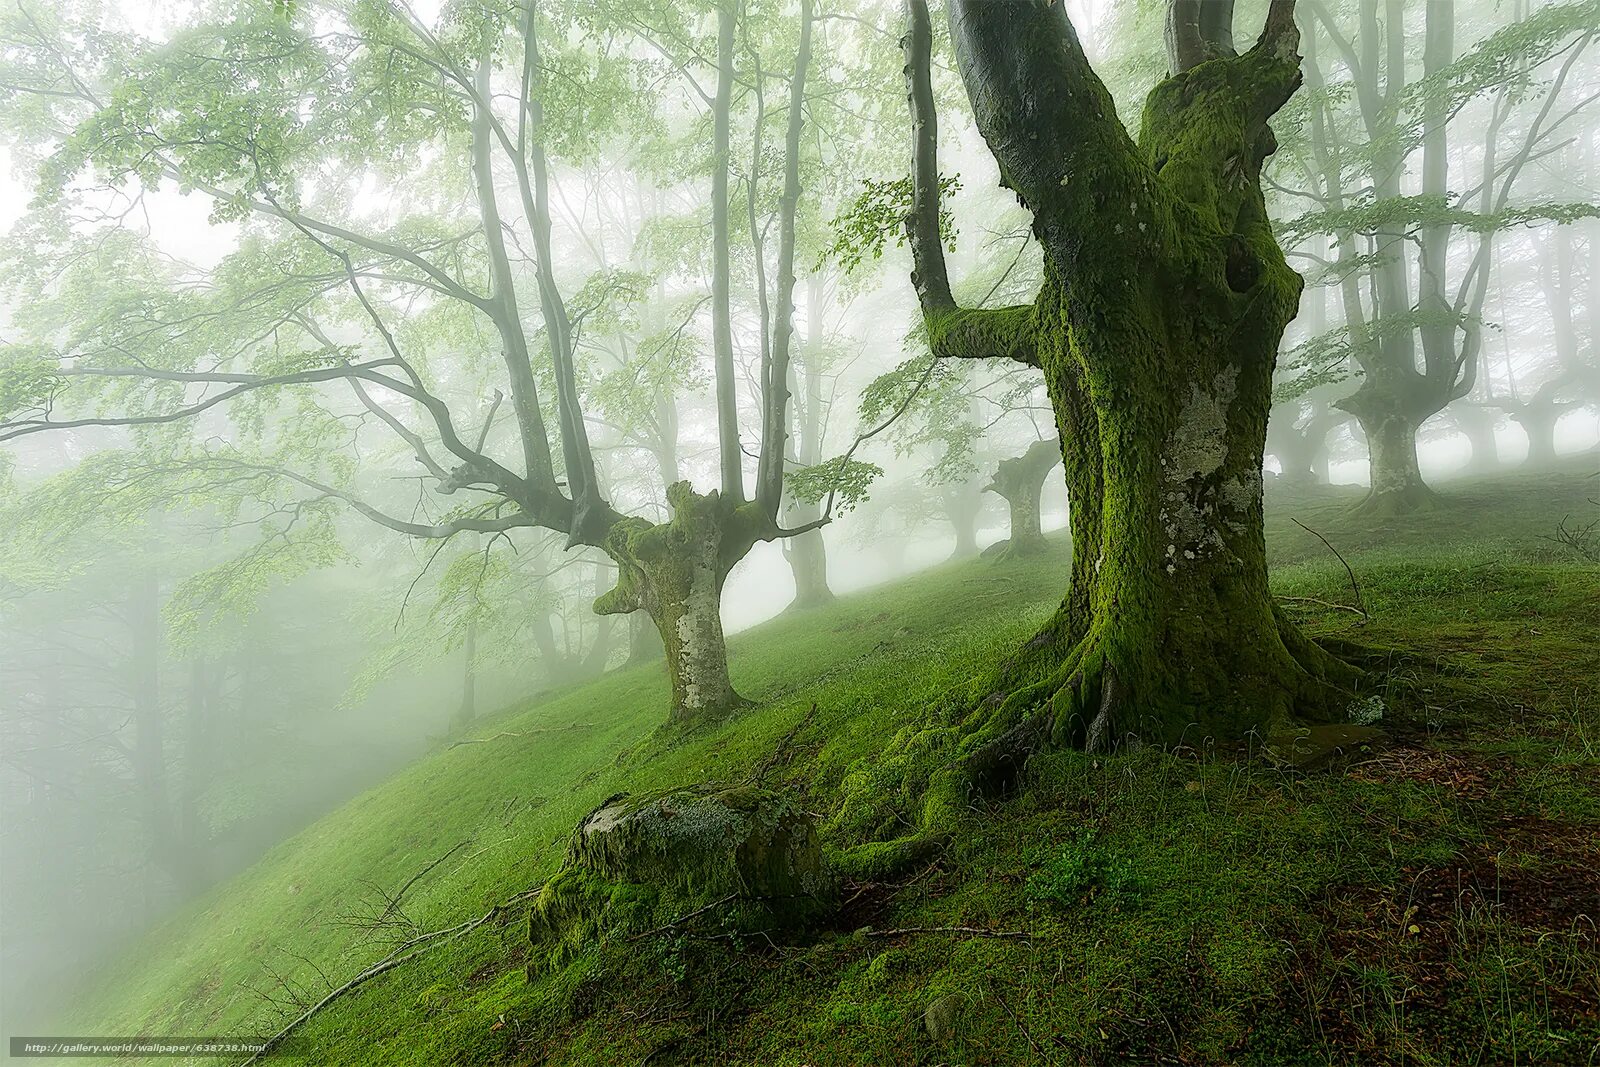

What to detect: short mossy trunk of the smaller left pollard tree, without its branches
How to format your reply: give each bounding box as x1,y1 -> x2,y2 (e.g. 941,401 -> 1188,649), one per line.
595,482 -> 771,725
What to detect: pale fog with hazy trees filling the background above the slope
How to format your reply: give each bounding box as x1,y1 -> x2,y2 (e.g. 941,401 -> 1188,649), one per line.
0,0 -> 1600,1055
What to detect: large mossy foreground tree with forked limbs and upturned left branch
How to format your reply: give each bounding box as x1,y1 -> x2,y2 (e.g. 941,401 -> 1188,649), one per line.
904,0 -> 1355,751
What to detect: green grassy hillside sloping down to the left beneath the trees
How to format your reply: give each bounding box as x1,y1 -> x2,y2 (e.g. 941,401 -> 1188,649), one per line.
62,459 -> 1600,1067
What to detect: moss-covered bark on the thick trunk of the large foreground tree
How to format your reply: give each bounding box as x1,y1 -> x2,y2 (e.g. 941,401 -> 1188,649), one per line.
989,27 -> 1349,747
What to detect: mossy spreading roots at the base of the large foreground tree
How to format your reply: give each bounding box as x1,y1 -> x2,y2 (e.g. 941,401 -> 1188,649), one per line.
827,605 -> 1362,883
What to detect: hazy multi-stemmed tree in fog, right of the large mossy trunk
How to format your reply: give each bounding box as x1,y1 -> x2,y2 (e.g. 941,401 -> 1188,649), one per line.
1275,0 -> 1600,514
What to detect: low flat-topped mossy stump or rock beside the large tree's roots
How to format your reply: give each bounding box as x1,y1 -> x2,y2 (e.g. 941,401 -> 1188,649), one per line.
528,785 -> 837,966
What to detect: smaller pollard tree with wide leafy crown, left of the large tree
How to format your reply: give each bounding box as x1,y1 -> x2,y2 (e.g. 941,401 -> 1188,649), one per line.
0,3 -> 902,718
